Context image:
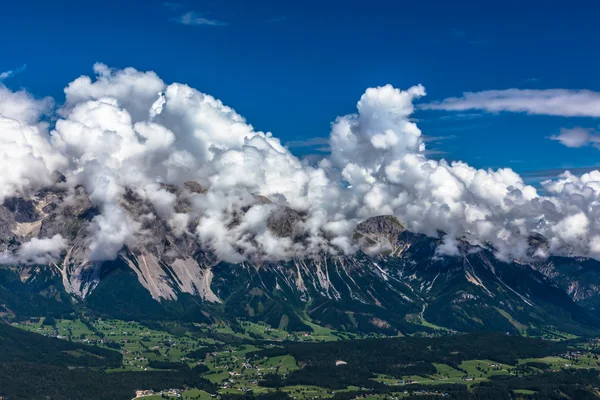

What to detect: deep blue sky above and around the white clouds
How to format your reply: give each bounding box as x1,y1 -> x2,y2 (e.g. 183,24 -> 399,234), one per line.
0,0 -> 600,177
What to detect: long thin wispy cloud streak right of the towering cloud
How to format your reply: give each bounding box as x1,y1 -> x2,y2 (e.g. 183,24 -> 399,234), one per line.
420,89 -> 600,117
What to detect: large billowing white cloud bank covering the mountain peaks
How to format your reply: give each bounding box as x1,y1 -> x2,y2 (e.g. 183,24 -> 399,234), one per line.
0,64 -> 600,262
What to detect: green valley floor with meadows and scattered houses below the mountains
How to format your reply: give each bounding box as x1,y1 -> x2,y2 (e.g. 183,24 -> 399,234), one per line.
0,315 -> 600,400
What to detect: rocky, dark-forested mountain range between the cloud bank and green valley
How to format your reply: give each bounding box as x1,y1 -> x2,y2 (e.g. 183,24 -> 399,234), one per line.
0,182 -> 600,337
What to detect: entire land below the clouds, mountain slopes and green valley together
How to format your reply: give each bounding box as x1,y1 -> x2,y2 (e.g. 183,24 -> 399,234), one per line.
0,192 -> 600,400
